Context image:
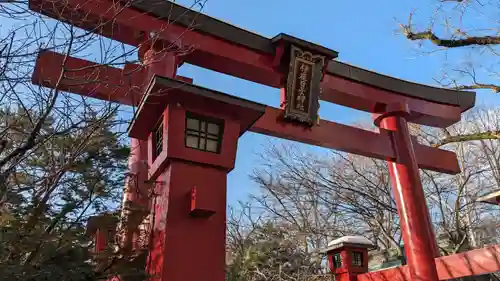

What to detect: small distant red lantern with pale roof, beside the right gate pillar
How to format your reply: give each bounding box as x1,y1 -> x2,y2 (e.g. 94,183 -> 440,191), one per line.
323,236 -> 374,281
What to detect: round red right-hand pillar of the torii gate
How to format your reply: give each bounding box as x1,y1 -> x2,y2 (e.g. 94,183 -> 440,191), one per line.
375,105 -> 438,281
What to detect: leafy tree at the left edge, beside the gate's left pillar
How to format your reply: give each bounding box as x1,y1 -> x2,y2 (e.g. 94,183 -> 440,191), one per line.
0,105 -> 141,281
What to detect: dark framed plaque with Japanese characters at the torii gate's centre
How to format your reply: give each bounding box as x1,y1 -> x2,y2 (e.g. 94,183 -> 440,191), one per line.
285,45 -> 325,126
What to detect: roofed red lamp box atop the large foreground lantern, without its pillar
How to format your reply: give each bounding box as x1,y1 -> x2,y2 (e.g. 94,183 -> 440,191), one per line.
129,76 -> 265,179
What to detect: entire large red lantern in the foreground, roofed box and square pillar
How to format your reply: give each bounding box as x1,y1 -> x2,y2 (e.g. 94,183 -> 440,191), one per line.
129,75 -> 266,281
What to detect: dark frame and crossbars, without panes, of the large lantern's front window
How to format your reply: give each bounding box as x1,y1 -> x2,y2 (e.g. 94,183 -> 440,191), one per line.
184,112 -> 224,154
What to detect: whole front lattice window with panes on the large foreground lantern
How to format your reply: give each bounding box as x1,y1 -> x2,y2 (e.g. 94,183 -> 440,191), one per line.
185,113 -> 224,153
